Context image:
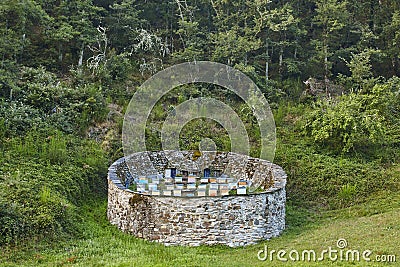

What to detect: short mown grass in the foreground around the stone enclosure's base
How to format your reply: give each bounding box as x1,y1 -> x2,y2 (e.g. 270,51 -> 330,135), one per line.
0,194 -> 400,266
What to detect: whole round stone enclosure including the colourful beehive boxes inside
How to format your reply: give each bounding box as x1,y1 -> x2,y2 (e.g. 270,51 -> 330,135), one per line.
107,151 -> 286,247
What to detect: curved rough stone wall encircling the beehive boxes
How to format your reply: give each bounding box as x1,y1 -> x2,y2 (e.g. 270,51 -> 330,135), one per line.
107,152 -> 286,247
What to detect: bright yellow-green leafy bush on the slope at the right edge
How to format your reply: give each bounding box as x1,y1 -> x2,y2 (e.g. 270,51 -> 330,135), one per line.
303,76 -> 400,152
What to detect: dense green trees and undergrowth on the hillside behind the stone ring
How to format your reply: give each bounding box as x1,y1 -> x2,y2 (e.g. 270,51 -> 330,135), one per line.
0,0 -> 400,266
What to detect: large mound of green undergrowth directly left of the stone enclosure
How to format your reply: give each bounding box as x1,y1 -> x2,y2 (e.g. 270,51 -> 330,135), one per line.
0,131 -> 107,245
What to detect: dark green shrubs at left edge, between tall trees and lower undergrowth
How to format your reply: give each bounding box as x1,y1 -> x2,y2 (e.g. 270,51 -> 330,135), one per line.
0,67 -> 108,136
